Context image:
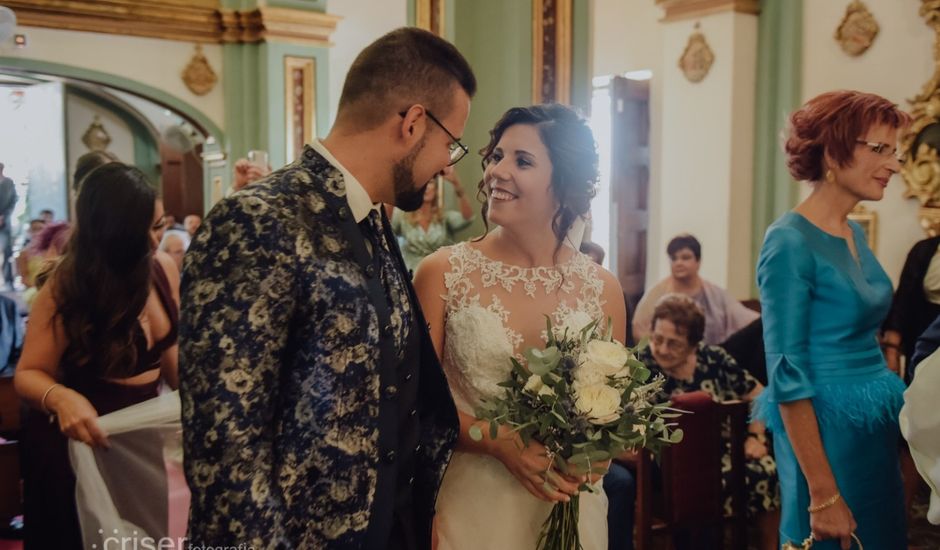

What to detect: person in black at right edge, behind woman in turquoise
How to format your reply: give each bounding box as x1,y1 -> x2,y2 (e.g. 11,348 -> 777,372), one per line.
881,237 -> 940,383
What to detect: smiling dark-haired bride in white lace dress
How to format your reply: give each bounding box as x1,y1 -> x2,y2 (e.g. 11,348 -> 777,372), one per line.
415,105 -> 626,550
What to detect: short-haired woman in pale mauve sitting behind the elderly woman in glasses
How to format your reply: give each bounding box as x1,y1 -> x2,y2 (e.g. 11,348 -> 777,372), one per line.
633,235 -> 759,344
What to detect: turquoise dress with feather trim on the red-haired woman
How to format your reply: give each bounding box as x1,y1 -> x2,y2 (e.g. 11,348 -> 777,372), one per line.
755,212 -> 907,550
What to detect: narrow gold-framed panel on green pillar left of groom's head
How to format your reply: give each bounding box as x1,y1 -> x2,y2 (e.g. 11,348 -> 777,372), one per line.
284,55 -> 317,166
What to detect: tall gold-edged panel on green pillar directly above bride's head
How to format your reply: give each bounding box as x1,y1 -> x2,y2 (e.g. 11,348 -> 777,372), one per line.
532,0 -> 571,103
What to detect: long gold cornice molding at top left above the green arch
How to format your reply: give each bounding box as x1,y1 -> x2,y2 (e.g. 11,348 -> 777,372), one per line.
4,0 -> 340,45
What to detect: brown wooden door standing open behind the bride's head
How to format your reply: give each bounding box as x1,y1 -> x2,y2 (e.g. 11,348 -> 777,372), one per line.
610,77 -> 650,342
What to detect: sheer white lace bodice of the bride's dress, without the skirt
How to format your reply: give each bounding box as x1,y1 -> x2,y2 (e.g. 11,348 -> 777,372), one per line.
442,243 -> 604,413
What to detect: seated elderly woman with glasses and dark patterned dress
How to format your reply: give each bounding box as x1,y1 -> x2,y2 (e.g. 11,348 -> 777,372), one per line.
637,294 -> 780,550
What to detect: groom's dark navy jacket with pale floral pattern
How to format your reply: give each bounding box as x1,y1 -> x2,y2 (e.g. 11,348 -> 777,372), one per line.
180,147 -> 458,549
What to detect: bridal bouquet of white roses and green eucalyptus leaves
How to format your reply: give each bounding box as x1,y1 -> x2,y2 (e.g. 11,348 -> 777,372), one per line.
470,319 -> 682,550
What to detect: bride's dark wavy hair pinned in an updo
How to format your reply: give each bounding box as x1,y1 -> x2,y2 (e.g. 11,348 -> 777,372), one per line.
477,103 -> 598,246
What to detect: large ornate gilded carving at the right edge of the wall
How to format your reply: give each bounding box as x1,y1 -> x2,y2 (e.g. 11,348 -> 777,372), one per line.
901,0 -> 940,234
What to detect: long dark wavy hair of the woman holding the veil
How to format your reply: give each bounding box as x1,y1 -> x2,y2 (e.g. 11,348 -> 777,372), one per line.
52,162 -> 157,377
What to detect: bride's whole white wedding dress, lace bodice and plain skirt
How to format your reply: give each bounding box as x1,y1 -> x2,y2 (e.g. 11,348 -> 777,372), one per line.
437,243 -> 607,550
